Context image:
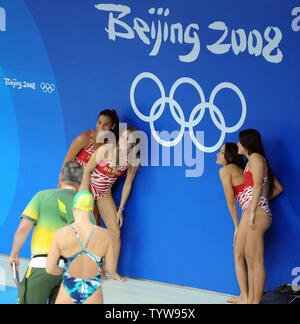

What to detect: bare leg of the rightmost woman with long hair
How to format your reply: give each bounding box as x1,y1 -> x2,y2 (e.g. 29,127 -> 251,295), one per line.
246,208 -> 272,304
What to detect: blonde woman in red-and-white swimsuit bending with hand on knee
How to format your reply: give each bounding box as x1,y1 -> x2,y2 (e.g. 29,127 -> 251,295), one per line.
79,126 -> 140,281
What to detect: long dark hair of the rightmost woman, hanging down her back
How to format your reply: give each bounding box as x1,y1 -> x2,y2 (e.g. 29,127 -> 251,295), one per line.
239,129 -> 274,196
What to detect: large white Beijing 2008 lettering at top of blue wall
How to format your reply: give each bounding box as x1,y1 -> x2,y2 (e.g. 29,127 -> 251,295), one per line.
95,4 -> 282,63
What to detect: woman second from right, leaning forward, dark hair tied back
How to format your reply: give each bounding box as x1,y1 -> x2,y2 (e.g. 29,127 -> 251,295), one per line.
217,143 -> 248,303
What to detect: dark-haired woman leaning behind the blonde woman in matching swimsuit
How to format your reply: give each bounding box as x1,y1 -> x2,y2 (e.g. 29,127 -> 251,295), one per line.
58,109 -> 119,225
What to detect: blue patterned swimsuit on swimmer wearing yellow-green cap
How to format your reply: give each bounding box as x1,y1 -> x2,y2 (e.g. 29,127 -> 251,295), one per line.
63,225 -> 102,304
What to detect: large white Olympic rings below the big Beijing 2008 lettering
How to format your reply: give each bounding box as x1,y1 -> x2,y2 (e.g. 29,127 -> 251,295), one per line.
130,72 -> 247,153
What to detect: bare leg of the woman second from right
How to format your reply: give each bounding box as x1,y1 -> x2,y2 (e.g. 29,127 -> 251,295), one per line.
233,213 -> 248,303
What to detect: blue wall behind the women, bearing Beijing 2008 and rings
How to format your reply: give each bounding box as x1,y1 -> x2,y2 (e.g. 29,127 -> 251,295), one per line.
0,0 -> 300,294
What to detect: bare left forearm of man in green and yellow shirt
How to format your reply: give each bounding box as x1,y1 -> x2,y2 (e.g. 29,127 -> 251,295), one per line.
8,218 -> 34,271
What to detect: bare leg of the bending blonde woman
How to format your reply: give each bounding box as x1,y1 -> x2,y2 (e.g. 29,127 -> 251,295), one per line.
97,194 -> 125,281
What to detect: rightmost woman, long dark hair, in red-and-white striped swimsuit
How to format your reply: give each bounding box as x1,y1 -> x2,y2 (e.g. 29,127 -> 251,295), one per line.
238,129 -> 283,304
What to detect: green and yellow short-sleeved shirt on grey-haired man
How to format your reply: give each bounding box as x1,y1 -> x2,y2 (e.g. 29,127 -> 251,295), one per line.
22,189 -> 95,257
